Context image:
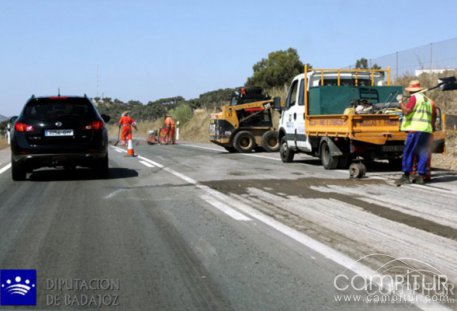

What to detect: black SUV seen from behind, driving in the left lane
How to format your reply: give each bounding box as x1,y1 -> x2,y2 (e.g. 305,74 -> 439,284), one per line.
11,95 -> 110,180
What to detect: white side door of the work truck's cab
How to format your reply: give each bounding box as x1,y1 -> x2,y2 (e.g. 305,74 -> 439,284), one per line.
283,79 -> 311,152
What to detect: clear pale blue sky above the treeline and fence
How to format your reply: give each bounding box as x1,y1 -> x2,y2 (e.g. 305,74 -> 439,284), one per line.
0,0 -> 457,116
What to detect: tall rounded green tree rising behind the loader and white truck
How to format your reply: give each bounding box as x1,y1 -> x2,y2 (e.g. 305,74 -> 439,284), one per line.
246,48 -> 304,89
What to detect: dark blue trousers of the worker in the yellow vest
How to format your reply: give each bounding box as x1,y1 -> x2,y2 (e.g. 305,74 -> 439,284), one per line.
402,132 -> 431,175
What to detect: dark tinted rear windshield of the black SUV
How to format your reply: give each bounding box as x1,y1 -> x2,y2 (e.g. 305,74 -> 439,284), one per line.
24,98 -> 96,121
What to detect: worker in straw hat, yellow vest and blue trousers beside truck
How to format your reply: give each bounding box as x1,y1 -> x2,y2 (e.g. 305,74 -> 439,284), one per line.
395,80 -> 436,186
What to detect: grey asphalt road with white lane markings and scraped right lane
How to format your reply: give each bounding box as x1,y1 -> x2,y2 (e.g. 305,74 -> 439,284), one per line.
0,143 -> 457,310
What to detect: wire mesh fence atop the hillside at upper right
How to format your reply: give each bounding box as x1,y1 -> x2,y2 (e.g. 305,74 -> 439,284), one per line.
360,38 -> 457,80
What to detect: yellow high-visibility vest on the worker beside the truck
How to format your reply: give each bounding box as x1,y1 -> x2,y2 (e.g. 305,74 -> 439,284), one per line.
400,94 -> 433,133
